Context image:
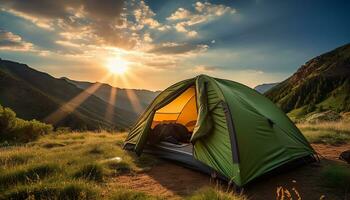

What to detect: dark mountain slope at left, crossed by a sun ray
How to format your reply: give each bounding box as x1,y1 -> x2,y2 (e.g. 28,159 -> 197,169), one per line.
0,59 -> 137,129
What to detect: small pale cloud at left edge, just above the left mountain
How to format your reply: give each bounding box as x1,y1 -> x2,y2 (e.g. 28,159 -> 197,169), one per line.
0,29 -> 33,51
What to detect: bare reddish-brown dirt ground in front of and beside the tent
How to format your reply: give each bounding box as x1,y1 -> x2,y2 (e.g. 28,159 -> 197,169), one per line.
108,144 -> 350,200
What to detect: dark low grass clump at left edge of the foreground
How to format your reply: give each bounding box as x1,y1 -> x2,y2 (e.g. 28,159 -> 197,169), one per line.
0,164 -> 58,187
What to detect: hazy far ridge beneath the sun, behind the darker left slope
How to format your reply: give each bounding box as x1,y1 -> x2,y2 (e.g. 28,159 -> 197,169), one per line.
61,77 -> 160,115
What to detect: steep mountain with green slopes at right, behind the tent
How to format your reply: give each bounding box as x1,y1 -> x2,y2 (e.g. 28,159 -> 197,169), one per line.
265,44 -> 350,116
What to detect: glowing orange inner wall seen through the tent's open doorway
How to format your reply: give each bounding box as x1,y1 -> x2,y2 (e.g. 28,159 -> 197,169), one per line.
152,86 -> 197,132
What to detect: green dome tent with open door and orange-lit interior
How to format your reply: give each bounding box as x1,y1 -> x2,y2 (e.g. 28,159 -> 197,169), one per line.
124,75 -> 315,186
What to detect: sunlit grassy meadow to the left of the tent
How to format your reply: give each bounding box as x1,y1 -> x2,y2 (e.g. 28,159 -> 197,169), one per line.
0,131 -> 161,199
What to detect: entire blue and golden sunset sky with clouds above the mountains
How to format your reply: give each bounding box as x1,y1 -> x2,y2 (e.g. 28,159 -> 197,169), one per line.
0,0 -> 350,90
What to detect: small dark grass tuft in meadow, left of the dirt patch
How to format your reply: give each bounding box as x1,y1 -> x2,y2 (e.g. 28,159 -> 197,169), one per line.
73,164 -> 103,181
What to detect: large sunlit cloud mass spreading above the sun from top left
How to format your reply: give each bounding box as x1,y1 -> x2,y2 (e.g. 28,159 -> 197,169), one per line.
0,0 -> 224,63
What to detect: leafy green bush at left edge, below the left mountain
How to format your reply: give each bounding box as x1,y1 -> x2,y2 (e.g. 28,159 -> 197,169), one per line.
0,106 -> 53,143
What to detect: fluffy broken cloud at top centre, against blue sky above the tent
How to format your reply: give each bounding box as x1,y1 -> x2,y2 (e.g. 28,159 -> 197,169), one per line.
166,2 -> 236,37
